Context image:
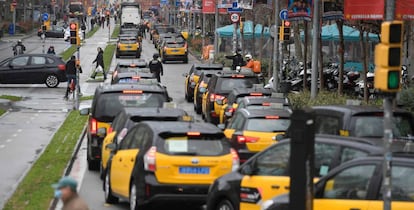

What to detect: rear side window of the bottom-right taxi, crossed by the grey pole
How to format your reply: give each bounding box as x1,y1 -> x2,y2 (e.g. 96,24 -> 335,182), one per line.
378,165 -> 414,201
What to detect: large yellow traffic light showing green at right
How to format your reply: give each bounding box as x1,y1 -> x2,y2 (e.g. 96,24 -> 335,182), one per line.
374,21 -> 403,93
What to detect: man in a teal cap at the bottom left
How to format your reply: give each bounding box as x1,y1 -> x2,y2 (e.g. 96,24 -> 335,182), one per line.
52,176 -> 89,210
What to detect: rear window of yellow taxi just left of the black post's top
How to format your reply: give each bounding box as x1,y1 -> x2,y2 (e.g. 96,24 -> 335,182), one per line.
246,118 -> 290,132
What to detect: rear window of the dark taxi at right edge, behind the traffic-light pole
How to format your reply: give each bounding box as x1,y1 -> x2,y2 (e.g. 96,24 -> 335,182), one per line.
351,115 -> 413,138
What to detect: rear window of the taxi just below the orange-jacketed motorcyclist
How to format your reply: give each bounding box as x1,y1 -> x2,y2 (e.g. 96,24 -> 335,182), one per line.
217,77 -> 259,93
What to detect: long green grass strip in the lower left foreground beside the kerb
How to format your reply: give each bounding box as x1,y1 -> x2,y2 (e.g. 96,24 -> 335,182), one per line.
4,111 -> 87,210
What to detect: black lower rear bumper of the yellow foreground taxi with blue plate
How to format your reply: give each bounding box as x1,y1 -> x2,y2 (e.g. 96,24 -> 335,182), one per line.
145,174 -> 210,203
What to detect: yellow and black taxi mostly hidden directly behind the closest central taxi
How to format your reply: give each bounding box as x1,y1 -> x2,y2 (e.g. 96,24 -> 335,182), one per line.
100,107 -> 188,178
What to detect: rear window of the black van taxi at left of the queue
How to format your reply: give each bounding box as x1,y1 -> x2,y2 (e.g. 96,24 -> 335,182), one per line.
94,92 -> 167,120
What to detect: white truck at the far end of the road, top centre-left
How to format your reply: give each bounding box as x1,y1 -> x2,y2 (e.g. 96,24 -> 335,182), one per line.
121,2 -> 141,27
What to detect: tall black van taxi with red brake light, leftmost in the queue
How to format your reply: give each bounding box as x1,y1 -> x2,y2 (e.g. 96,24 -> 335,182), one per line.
81,83 -> 172,170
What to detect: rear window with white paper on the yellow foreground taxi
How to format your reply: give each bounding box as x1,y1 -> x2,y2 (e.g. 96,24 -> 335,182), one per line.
158,136 -> 230,156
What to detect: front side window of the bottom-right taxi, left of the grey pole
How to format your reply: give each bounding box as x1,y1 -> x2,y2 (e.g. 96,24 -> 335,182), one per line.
323,164 -> 376,200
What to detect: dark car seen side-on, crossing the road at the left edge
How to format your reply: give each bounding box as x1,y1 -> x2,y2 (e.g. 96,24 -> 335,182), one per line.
0,54 -> 67,88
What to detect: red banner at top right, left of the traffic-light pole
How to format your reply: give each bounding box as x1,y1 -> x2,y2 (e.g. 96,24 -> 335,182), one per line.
344,0 -> 385,20
